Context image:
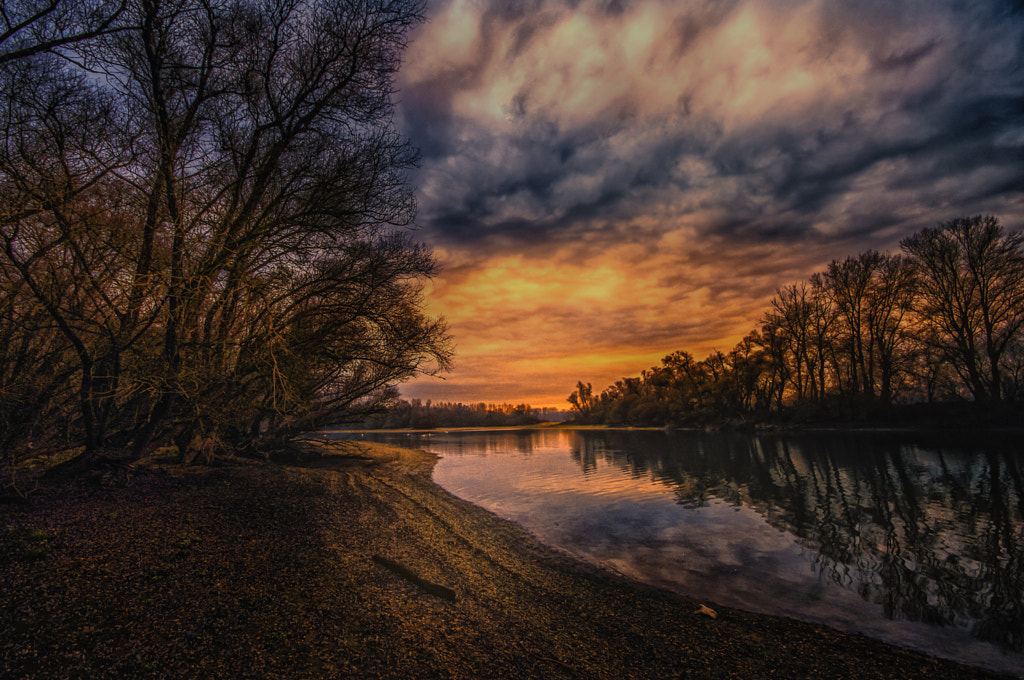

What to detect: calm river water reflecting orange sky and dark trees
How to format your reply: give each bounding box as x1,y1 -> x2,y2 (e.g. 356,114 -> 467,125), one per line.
331,430 -> 1024,676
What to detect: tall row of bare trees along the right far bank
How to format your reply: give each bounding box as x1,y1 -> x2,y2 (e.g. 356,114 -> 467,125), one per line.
568,216 -> 1024,425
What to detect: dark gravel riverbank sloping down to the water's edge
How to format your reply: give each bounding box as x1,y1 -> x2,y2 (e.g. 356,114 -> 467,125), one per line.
0,443 -> 996,679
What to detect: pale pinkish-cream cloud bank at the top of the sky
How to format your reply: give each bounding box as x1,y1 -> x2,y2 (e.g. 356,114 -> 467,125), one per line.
403,0 -> 930,131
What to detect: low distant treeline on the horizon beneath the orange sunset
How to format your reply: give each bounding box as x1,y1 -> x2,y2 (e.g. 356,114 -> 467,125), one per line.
365,399 -> 566,429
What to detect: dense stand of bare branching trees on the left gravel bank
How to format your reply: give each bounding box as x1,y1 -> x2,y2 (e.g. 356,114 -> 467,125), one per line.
0,0 -> 452,463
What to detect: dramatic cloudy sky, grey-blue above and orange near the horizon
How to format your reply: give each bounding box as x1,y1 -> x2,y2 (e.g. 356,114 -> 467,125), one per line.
396,0 -> 1024,408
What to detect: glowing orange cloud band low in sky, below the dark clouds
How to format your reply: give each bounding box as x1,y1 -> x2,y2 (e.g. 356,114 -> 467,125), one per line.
401,228 -> 823,408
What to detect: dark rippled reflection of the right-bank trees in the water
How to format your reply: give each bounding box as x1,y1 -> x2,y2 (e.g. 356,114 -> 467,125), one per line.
571,431 -> 1024,651
